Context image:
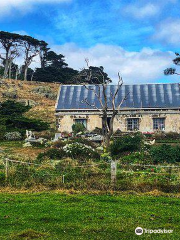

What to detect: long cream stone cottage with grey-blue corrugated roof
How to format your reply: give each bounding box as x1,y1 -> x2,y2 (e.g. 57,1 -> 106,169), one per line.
55,83 -> 180,133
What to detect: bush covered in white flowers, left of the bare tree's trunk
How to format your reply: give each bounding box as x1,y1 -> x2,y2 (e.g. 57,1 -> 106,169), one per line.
63,142 -> 100,160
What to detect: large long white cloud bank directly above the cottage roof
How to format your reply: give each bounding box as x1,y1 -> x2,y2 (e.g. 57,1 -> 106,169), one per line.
52,43 -> 174,83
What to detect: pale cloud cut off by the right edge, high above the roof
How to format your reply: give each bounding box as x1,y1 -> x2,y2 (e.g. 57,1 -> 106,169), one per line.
153,19 -> 180,45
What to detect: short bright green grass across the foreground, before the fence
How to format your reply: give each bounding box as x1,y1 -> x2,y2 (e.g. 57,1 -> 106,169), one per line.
0,192 -> 180,240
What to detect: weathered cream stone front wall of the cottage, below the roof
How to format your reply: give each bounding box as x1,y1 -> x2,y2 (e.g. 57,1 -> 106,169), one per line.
56,111 -> 180,133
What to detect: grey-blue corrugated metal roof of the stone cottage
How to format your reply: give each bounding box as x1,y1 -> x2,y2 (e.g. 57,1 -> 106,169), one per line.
56,83 -> 180,110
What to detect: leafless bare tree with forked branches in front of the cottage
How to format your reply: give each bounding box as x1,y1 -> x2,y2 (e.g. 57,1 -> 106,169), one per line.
82,59 -> 129,147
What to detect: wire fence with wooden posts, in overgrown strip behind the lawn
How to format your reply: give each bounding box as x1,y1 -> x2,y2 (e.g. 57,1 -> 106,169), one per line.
2,158 -> 180,192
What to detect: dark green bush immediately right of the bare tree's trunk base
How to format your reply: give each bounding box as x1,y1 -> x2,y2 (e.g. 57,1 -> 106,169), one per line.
110,133 -> 143,157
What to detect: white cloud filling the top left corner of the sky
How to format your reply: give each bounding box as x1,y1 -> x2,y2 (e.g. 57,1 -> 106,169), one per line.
0,0 -> 71,17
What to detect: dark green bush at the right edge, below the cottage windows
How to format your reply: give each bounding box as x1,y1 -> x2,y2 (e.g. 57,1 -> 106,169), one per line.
150,144 -> 180,164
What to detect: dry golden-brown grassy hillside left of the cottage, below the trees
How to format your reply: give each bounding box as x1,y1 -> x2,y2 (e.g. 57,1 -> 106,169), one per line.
0,80 -> 59,124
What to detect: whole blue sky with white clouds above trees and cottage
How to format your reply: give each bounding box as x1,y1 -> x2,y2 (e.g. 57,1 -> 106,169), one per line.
0,0 -> 180,84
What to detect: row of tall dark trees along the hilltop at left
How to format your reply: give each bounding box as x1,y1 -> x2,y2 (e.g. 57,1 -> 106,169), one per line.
0,31 -> 111,84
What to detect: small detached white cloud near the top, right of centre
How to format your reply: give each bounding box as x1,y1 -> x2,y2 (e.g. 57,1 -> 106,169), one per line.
124,3 -> 160,19
